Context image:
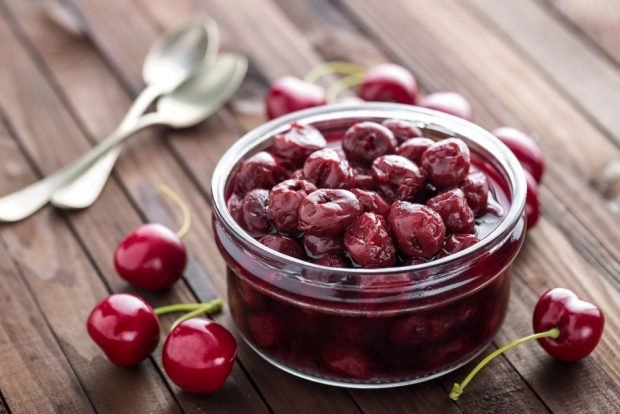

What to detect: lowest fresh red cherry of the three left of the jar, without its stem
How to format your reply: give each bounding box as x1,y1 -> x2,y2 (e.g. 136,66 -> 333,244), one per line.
162,318 -> 237,394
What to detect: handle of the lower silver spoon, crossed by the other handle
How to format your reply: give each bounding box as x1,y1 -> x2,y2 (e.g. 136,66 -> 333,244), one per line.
51,85 -> 162,209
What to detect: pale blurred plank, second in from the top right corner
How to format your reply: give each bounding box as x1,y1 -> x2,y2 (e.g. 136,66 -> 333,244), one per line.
472,0 -> 620,149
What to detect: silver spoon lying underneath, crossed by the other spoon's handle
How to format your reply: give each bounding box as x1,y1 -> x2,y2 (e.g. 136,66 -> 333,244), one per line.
51,19 -> 219,208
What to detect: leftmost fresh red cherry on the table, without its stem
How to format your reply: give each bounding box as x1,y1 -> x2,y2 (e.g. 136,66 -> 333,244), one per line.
86,293 -> 159,367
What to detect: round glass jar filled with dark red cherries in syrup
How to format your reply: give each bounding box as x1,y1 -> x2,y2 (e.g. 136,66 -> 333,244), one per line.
213,104 -> 525,387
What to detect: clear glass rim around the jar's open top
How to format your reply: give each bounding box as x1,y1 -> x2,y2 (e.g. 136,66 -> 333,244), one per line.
211,102 -> 527,275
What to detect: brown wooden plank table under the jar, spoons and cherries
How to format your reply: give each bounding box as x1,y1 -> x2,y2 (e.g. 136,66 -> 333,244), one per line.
0,0 -> 620,414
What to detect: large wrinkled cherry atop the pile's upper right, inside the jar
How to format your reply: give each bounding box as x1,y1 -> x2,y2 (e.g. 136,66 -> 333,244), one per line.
422,138 -> 471,188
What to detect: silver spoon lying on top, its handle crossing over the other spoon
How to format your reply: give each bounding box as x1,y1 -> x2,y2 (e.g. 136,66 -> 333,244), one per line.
0,53 -> 248,222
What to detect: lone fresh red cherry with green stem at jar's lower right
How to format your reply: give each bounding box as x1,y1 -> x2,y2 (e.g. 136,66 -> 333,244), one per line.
450,288 -> 605,401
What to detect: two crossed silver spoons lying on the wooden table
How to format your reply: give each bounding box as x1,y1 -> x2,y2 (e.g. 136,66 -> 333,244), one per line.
0,20 -> 248,222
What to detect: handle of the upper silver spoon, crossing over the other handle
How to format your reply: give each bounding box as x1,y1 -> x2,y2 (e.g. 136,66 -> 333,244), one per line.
0,114 -> 162,222
